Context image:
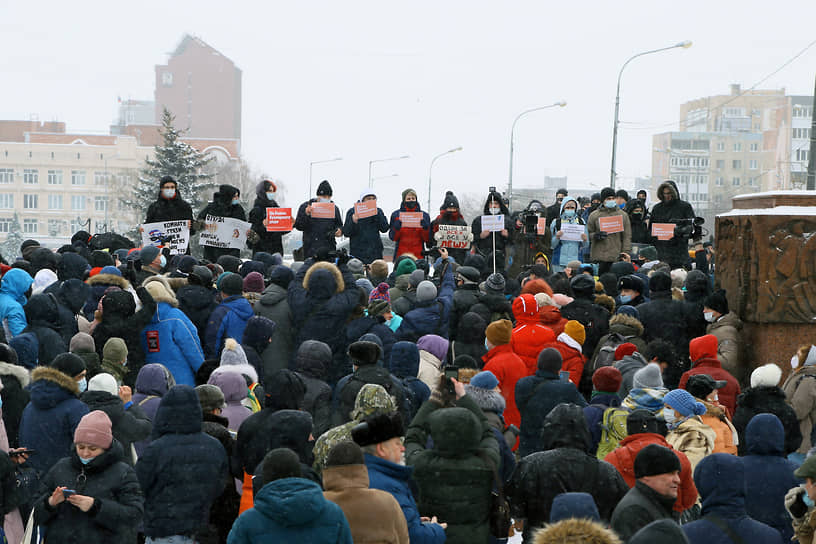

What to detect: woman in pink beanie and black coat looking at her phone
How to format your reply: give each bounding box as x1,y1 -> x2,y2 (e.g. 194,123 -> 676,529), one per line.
34,410 -> 144,544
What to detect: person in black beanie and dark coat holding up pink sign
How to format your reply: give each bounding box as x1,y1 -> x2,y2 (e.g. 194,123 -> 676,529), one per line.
295,179 -> 343,259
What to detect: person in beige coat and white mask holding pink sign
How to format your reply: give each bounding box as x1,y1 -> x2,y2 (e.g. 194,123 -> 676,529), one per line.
587,187 -> 632,275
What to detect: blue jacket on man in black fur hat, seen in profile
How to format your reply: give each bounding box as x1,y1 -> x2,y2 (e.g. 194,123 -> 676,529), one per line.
365,453 -> 446,544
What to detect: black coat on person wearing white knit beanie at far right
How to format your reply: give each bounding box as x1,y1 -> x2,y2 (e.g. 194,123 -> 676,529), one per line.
732,382 -> 802,455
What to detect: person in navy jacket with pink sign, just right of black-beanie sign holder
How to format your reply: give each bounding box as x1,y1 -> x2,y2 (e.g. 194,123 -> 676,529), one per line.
343,189 -> 388,264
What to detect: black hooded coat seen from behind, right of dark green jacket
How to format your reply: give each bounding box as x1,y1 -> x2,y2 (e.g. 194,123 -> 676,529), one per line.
506,402 -> 629,542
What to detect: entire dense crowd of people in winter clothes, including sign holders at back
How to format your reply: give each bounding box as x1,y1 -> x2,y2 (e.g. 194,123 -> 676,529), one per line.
0,177 -> 816,544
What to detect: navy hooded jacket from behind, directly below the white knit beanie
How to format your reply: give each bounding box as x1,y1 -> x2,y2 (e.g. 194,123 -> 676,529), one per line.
742,414 -> 800,542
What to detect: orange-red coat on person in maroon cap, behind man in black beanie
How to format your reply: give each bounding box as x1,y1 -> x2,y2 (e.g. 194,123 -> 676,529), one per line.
604,433 -> 697,512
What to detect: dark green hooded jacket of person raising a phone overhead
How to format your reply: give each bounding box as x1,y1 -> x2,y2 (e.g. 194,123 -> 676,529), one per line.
405,395 -> 499,544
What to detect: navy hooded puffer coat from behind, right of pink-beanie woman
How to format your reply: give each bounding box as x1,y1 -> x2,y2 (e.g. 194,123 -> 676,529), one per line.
136,385 -> 227,538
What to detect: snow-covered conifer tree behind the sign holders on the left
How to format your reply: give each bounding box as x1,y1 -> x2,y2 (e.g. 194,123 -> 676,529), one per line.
122,108 -> 215,215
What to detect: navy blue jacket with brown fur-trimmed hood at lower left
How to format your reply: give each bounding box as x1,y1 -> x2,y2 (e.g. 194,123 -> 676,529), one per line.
20,366 -> 88,473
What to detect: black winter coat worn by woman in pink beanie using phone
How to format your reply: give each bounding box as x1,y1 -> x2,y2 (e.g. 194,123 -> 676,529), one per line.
34,440 -> 144,544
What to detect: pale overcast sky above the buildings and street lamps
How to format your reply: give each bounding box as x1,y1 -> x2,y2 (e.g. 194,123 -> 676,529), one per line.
0,0 -> 816,214
